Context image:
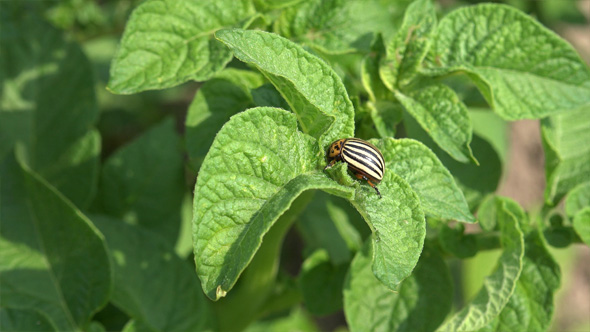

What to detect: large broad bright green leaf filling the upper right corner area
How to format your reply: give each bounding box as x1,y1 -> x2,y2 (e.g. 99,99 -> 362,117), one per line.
429,4 -> 590,120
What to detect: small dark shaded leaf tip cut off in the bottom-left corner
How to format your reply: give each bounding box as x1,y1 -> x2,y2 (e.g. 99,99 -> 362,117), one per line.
0,307 -> 56,332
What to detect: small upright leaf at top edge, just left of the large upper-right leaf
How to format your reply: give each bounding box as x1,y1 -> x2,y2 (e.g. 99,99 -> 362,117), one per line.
379,0 -> 436,91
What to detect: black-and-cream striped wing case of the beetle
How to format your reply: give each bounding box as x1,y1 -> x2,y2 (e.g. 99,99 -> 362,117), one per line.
342,138 -> 385,181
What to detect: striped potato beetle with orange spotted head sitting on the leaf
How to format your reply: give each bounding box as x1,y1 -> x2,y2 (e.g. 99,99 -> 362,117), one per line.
324,138 -> 385,198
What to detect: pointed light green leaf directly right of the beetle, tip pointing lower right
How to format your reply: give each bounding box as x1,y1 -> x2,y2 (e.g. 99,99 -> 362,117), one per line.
377,138 -> 475,222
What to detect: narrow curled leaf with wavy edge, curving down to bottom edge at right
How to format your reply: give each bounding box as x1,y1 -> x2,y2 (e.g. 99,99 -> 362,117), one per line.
438,199 -> 524,331
